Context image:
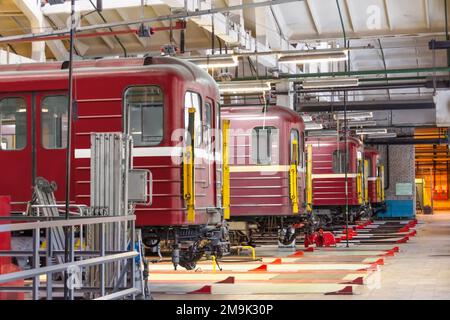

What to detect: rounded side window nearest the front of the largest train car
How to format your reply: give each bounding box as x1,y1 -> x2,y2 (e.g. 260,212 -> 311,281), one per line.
125,86 -> 164,147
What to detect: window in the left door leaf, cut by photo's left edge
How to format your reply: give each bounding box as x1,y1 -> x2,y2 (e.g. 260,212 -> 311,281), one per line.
0,98 -> 27,150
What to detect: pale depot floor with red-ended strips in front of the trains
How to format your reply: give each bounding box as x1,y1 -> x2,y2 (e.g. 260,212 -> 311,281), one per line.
149,218 -> 450,300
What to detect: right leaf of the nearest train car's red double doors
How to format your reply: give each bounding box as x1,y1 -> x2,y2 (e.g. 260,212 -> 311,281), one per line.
34,93 -> 68,201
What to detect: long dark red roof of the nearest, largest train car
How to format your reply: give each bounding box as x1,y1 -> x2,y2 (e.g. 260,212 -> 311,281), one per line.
0,56 -> 219,96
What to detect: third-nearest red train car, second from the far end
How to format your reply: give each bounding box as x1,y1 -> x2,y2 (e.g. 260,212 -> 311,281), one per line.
306,136 -> 367,225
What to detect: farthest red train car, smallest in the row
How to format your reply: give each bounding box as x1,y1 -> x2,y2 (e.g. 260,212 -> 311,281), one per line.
364,147 -> 384,212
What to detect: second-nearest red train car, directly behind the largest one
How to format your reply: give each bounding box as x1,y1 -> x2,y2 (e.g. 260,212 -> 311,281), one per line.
221,106 -> 307,244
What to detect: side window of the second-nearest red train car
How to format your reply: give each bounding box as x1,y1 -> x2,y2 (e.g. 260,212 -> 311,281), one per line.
252,127 -> 278,165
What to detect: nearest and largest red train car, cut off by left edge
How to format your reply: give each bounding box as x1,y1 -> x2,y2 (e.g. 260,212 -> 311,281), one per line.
0,57 -> 229,267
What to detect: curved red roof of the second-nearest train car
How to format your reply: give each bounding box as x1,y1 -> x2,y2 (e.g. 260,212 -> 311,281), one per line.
221,106 -> 303,125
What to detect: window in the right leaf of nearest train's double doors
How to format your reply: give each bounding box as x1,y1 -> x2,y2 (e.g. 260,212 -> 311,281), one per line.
41,95 -> 68,149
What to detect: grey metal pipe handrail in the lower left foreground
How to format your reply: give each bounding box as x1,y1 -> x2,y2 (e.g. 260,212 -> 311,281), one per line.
0,212 -> 140,300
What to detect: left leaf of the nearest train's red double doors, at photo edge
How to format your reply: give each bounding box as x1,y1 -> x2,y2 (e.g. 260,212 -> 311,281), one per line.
0,93 -> 34,206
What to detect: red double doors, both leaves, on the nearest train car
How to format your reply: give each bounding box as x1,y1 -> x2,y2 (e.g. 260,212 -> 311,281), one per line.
0,93 -> 67,210
